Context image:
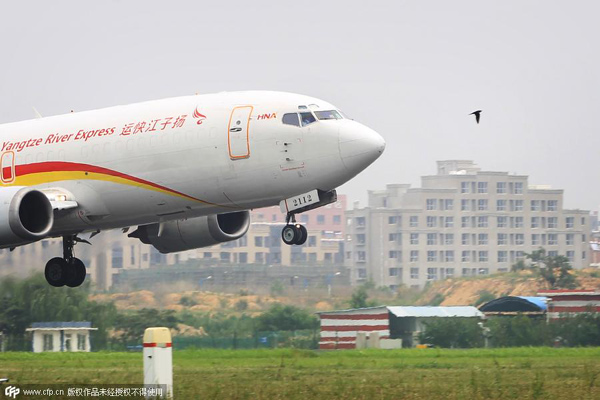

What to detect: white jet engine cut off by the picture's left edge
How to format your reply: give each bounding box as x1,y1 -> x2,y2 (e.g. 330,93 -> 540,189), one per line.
0,187 -> 54,247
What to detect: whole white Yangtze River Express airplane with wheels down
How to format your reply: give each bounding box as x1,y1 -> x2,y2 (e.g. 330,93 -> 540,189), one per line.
0,91 -> 385,287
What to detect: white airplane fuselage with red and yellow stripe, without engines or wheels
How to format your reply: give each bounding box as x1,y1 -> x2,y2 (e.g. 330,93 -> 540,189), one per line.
0,92 -> 385,241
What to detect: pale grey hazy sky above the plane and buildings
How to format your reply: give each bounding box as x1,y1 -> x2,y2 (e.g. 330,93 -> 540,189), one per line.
0,0 -> 600,210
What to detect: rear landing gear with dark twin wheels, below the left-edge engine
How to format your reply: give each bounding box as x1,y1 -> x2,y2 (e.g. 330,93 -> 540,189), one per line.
44,235 -> 90,287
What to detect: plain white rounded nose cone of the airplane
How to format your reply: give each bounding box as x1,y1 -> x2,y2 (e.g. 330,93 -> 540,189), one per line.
340,123 -> 385,174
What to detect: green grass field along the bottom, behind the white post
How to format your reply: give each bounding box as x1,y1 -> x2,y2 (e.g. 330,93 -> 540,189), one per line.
0,348 -> 600,400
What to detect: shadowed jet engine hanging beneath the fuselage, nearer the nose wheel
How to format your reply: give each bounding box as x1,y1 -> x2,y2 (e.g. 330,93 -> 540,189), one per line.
129,211 -> 250,254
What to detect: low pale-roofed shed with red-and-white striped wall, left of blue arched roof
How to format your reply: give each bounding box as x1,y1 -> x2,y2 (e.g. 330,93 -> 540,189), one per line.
317,306 -> 484,349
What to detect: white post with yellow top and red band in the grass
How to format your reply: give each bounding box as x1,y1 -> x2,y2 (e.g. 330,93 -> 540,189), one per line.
144,328 -> 173,398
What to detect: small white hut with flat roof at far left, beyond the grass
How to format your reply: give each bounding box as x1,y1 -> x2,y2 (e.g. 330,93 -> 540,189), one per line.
25,322 -> 98,353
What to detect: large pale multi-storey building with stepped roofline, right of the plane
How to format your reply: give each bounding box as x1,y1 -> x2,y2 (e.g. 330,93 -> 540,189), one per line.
345,160 -> 591,289
